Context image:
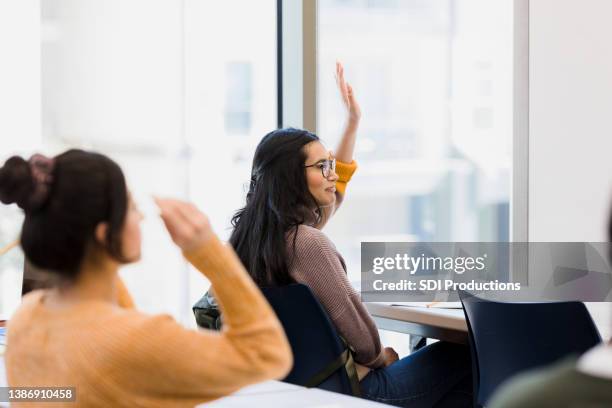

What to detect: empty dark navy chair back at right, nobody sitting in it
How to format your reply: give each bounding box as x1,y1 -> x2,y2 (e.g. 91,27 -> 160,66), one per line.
459,291 -> 601,407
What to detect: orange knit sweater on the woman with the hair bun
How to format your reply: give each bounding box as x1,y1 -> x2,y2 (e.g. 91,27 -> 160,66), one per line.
5,237 -> 292,408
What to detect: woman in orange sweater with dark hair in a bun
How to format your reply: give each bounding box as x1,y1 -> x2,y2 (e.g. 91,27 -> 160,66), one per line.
0,150 -> 292,407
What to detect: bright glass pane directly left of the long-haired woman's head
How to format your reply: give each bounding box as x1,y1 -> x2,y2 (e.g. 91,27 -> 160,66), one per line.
185,0 -> 277,320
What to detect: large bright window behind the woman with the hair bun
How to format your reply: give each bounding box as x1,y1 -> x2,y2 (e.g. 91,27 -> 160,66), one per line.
0,0 -> 277,325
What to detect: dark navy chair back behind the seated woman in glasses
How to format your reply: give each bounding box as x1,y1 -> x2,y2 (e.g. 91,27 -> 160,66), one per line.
261,284 -> 360,396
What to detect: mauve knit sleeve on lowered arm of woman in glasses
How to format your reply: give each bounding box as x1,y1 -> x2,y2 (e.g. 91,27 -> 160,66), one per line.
289,227 -> 384,368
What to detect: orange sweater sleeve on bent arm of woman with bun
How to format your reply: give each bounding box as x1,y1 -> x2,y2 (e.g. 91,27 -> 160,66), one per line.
106,237 -> 292,406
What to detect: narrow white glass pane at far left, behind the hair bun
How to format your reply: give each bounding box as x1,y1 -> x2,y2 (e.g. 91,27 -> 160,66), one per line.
0,1 -> 41,320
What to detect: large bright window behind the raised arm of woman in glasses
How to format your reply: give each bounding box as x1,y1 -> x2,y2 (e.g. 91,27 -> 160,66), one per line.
317,0 -> 513,280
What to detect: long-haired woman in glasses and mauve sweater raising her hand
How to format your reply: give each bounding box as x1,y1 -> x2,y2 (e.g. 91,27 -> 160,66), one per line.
230,64 -> 472,407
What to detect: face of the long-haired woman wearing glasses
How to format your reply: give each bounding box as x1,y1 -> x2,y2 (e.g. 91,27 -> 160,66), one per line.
304,141 -> 338,207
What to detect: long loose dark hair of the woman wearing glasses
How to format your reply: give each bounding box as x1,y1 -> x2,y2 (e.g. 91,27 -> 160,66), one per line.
230,128 -> 321,286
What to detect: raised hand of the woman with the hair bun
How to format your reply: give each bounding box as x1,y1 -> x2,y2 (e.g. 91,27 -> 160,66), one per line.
155,198 -> 215,252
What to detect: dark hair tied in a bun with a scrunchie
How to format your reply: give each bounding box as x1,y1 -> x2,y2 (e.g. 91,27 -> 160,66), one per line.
0,150 -> 128,281
